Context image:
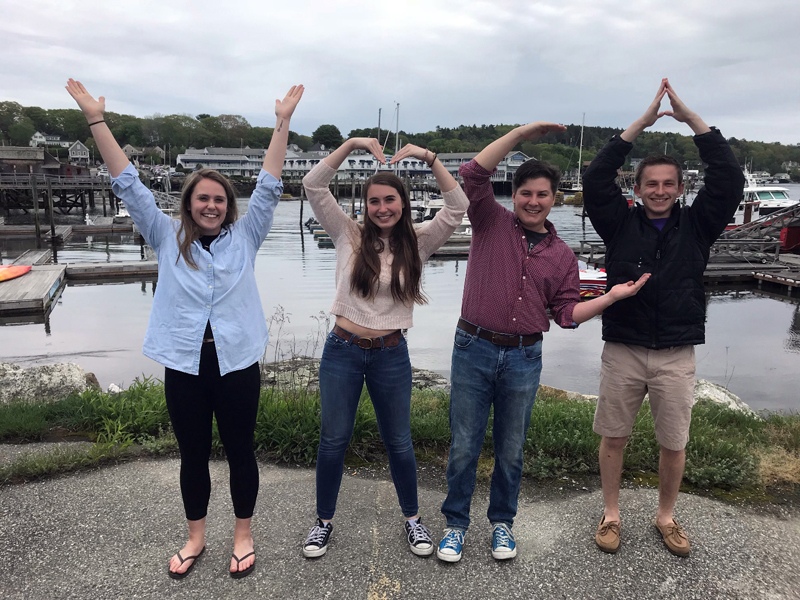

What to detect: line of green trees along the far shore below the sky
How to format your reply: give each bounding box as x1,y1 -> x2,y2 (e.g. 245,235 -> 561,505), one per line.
0,101 -> 800,176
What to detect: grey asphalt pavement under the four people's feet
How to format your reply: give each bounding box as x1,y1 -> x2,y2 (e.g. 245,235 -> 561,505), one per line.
0,459 -> 800,600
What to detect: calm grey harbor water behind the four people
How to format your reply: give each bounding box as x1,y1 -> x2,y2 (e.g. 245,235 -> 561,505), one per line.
0,198 -> 800,410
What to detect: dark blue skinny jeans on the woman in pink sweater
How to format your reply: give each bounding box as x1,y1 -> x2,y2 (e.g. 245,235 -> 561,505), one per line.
317,332 -> 419,520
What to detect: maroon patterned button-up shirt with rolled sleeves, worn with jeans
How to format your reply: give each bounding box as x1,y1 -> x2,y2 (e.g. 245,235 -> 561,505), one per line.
459,160 -> 580,335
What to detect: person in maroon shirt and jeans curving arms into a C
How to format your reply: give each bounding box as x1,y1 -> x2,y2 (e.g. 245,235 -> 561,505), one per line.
437,122 -> 649,562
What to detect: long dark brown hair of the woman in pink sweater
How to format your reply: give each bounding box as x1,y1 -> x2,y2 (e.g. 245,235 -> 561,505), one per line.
350,173 -> 428,304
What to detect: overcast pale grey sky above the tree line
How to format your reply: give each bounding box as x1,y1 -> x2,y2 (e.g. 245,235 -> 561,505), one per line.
0,0 -> 800,144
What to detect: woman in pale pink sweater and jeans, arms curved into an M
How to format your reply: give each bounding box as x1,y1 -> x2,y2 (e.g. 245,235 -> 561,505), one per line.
303,138 -> 469,558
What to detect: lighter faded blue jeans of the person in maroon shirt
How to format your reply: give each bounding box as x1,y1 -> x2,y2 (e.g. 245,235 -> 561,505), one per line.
442,329 -> 542,531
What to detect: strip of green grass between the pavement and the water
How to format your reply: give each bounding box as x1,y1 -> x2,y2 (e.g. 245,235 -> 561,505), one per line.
0,379 -> 800,490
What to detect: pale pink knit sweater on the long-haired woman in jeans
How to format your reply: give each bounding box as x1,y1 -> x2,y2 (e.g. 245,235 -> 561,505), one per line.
303,161 -> 469,329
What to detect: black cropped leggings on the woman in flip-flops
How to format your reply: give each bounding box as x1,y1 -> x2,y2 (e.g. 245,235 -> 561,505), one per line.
164,343 -> 261,521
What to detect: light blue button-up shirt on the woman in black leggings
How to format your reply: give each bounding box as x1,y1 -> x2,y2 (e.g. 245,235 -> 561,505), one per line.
112,164 -> 283,375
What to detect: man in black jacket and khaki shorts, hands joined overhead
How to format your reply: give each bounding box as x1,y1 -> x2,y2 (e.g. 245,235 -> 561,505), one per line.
583,79 -> 744,556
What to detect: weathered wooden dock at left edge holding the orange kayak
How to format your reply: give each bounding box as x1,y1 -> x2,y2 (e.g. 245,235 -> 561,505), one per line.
0,265 -> 67,316
